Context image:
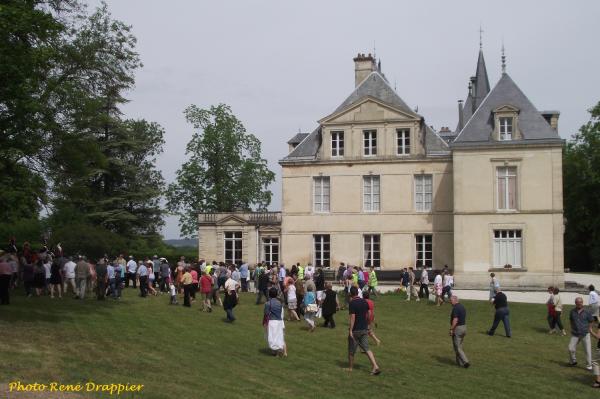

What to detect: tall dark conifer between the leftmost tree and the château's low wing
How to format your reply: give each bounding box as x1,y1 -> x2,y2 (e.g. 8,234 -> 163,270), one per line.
52,4 -> 164,237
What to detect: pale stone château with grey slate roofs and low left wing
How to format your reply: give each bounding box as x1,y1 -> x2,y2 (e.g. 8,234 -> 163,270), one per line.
199,45 -> 564,287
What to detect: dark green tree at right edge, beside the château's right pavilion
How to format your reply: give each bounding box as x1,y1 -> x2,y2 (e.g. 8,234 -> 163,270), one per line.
563,102 -> 600,271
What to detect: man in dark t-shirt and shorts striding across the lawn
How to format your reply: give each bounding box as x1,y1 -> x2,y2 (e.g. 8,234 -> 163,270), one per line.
348,286 -> 381,375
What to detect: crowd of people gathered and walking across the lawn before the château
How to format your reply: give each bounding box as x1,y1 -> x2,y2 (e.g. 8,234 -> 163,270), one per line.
0,240 -> 600,388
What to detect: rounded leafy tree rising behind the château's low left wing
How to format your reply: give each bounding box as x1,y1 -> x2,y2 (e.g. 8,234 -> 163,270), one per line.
167,104 -> 275,237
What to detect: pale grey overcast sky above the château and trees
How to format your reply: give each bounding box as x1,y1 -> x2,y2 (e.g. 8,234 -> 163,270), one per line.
89,0 -> 600,238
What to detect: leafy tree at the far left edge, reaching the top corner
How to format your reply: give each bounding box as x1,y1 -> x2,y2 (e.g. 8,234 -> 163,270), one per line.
0,0 -> 80,222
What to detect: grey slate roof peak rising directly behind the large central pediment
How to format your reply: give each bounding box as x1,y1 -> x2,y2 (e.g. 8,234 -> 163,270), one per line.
333,71 -> 420,118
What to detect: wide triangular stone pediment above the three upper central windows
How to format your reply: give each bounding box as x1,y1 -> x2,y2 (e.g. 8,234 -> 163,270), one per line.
319,97 -> 418,124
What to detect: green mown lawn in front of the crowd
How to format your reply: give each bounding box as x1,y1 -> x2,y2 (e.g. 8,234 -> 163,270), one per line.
0,289 -> 599,398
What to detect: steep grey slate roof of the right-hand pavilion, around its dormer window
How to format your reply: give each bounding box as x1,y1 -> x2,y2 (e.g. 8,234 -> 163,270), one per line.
451,73 -> 562,146
